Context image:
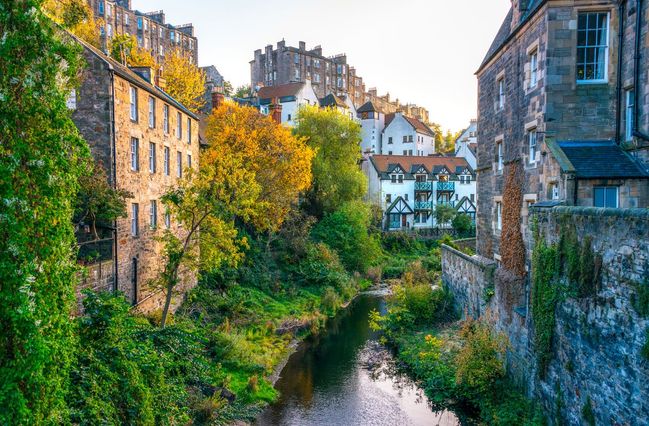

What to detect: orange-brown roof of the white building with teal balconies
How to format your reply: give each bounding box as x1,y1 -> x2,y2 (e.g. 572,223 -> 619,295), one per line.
370,155 -> 475,180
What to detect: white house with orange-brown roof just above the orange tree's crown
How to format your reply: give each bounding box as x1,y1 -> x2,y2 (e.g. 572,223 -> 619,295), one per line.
257,80 -> 320,127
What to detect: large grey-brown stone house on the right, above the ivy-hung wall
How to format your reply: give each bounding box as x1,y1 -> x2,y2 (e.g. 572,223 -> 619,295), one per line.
476,0 -> 649,260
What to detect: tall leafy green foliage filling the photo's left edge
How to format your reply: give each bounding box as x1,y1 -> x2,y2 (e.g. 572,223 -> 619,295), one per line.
0,0 -> 89,424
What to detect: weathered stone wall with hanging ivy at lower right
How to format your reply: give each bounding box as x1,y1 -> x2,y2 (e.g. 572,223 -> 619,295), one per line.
442,207 -> 649,425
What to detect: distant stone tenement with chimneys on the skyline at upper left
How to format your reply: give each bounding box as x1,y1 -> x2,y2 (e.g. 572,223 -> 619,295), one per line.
88,0 -> 198,64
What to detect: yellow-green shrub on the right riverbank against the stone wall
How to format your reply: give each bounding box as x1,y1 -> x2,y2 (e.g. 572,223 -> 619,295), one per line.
455,321 -> 507,401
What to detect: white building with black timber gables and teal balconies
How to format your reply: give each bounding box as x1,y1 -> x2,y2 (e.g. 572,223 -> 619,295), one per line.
363,155 -> 477,230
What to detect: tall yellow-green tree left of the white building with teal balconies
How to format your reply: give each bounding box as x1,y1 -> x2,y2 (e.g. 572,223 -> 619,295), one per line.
294,106 -> 367,217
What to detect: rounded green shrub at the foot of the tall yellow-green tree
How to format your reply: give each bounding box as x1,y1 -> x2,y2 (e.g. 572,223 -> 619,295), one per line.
312,201 -> 381,273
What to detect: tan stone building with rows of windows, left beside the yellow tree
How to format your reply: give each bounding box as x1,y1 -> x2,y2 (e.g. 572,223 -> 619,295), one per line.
69,36 -> 199,311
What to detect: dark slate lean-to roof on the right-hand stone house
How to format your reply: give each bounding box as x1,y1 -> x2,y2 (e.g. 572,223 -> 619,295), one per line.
548,140 -> 649,179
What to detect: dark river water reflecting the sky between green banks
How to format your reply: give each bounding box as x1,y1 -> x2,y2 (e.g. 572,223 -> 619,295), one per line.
256,295 -> 460,426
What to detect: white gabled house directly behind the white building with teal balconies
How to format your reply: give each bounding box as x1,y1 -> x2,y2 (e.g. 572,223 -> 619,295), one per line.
380,112 -> 435,157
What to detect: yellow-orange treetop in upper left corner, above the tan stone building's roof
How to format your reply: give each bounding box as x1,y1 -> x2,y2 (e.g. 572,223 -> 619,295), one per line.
42,0 -> 101,48
